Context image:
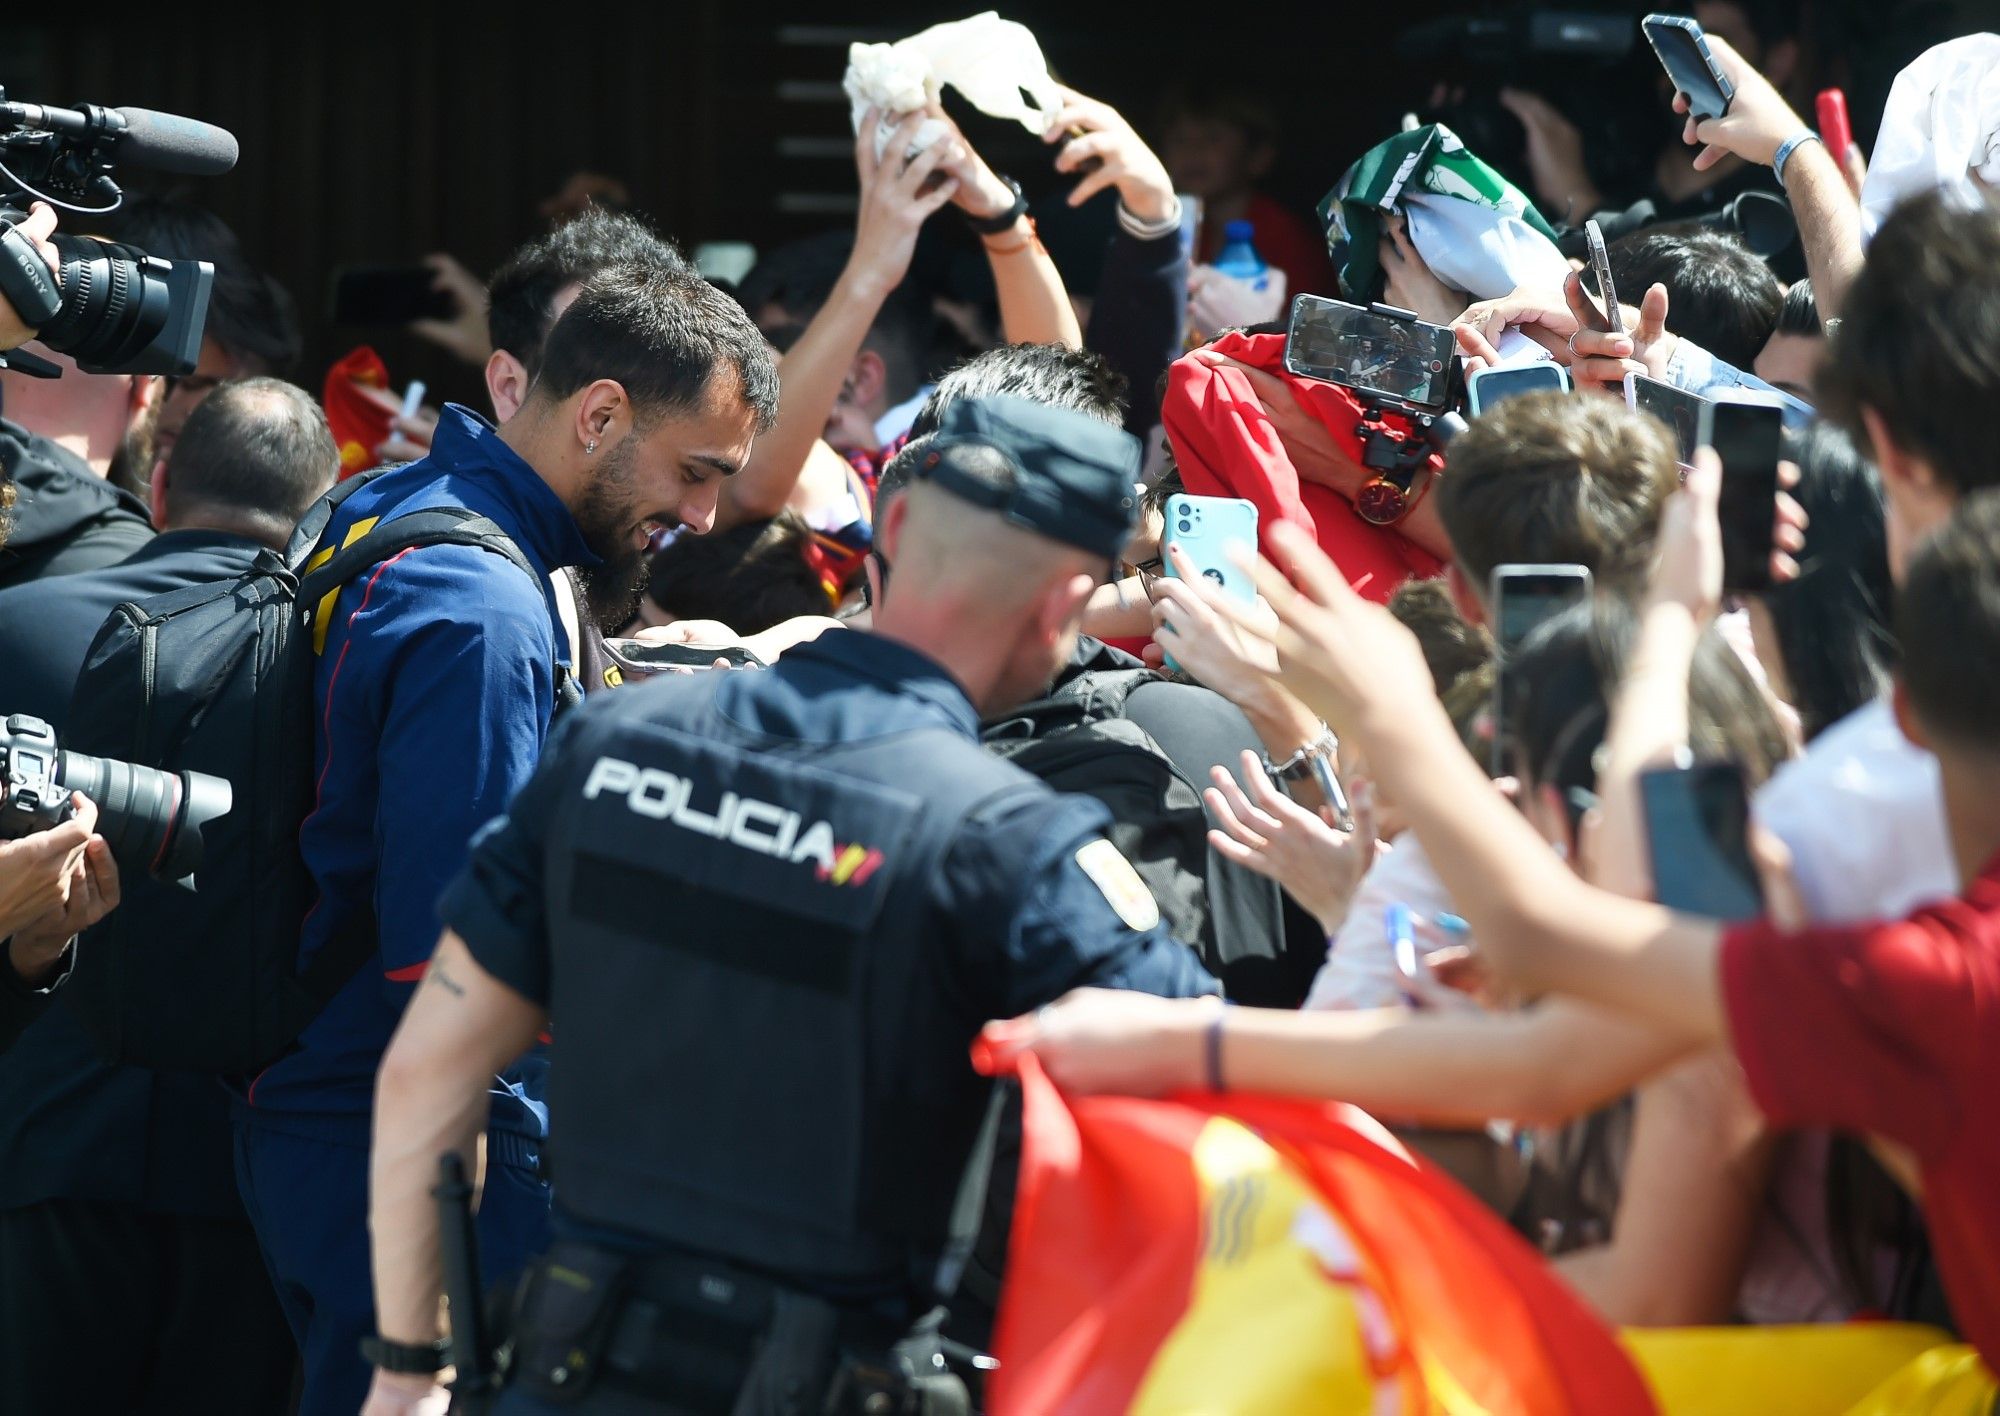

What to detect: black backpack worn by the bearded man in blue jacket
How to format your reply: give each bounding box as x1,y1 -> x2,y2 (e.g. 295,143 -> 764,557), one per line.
64,468 -> 576,1074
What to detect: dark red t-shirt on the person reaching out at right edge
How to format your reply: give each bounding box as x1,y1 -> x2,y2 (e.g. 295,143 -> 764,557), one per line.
1722,856 -> 2000,1370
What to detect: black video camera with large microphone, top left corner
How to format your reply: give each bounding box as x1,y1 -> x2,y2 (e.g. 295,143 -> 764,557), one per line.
0,88 -> 236,378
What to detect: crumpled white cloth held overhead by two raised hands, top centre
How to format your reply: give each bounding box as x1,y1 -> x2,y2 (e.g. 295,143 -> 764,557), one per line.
840,10 -> 1062,156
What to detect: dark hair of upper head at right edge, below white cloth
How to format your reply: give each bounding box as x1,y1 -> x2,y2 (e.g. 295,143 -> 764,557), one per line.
1818,192 -> 2000,494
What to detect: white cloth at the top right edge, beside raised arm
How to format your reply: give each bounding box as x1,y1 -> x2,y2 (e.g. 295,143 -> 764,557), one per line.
1836,34 -> 2000,236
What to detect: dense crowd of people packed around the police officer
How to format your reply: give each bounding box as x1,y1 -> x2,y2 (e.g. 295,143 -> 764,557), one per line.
0,0 -> 2000,1412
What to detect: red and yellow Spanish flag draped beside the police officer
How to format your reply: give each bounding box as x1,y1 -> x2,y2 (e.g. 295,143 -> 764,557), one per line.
990,1056 -> 1654,1416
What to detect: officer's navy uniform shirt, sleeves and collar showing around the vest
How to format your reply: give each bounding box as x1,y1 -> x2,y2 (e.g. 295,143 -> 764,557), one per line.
442,630 -> 1218,1016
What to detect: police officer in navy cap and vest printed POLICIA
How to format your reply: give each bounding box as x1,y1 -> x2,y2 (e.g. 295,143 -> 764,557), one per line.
366,398 -> 1214,1414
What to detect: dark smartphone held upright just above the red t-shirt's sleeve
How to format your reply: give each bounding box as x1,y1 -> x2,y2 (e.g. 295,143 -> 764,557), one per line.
1638,762 -> 1764,920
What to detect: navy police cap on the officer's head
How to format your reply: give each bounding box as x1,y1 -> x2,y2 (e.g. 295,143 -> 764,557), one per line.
916,396 -> 1140,562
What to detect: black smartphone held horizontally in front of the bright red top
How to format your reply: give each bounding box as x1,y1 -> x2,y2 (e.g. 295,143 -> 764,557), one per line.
1284,296 -> 1464,412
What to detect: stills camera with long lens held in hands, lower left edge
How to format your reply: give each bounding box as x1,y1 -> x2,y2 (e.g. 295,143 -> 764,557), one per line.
0,714 -> 234,880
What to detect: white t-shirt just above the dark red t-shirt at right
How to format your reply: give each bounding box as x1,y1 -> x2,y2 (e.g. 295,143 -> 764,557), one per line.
1752,698 -> 1958,924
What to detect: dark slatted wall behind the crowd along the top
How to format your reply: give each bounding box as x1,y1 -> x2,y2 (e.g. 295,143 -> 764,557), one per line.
0,0 -> 1990,398
